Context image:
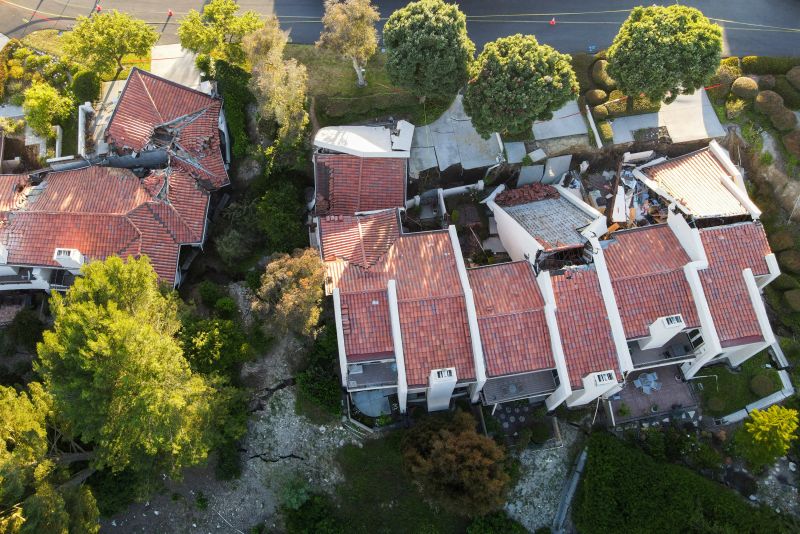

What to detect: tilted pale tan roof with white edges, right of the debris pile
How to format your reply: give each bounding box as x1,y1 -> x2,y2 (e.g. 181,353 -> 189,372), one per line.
634,141 -> 761,219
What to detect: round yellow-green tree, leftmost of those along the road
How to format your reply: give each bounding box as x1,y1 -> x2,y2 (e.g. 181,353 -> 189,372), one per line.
64,10 -> 158,80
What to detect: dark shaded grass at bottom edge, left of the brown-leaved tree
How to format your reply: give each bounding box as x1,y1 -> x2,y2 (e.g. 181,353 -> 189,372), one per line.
336,431 -> 468,534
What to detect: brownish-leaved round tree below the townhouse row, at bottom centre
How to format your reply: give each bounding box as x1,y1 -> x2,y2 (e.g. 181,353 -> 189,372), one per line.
403,411 -> 510,516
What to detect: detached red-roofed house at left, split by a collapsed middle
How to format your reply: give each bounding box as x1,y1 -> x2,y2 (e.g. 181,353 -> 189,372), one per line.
0,69 -> 229,291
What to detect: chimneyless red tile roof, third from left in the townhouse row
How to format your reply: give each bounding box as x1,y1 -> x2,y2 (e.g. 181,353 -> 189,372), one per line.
467,261 -> 555,377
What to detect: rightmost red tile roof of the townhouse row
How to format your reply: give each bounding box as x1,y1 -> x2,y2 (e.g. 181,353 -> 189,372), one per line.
700,223 -> 771,347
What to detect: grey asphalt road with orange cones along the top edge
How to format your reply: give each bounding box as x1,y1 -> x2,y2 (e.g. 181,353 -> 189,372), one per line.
0,0 -> 800,55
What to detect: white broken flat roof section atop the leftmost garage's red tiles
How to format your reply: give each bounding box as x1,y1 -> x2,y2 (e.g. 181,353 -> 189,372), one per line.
314,120 -> 414,158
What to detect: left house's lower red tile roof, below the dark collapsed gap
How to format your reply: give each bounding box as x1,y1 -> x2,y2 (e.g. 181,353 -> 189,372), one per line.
0,166 -> 209,283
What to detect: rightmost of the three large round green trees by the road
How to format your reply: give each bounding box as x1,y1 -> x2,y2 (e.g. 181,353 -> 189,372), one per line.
608,4 -> 722,102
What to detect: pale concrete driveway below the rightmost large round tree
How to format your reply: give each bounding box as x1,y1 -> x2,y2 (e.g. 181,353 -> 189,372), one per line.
611,89 -> 726,144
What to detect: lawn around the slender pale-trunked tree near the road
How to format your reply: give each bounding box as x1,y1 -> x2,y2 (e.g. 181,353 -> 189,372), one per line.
286,44 -> 455,126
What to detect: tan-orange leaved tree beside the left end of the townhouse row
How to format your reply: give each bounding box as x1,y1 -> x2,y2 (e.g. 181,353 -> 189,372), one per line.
256,248 -> 325,336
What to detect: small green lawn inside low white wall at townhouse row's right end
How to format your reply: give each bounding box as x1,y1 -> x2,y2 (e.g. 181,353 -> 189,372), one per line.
696,352 -> 781,416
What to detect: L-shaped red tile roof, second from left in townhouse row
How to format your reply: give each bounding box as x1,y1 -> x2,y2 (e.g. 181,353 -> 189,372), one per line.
320,227 -> 475,387
